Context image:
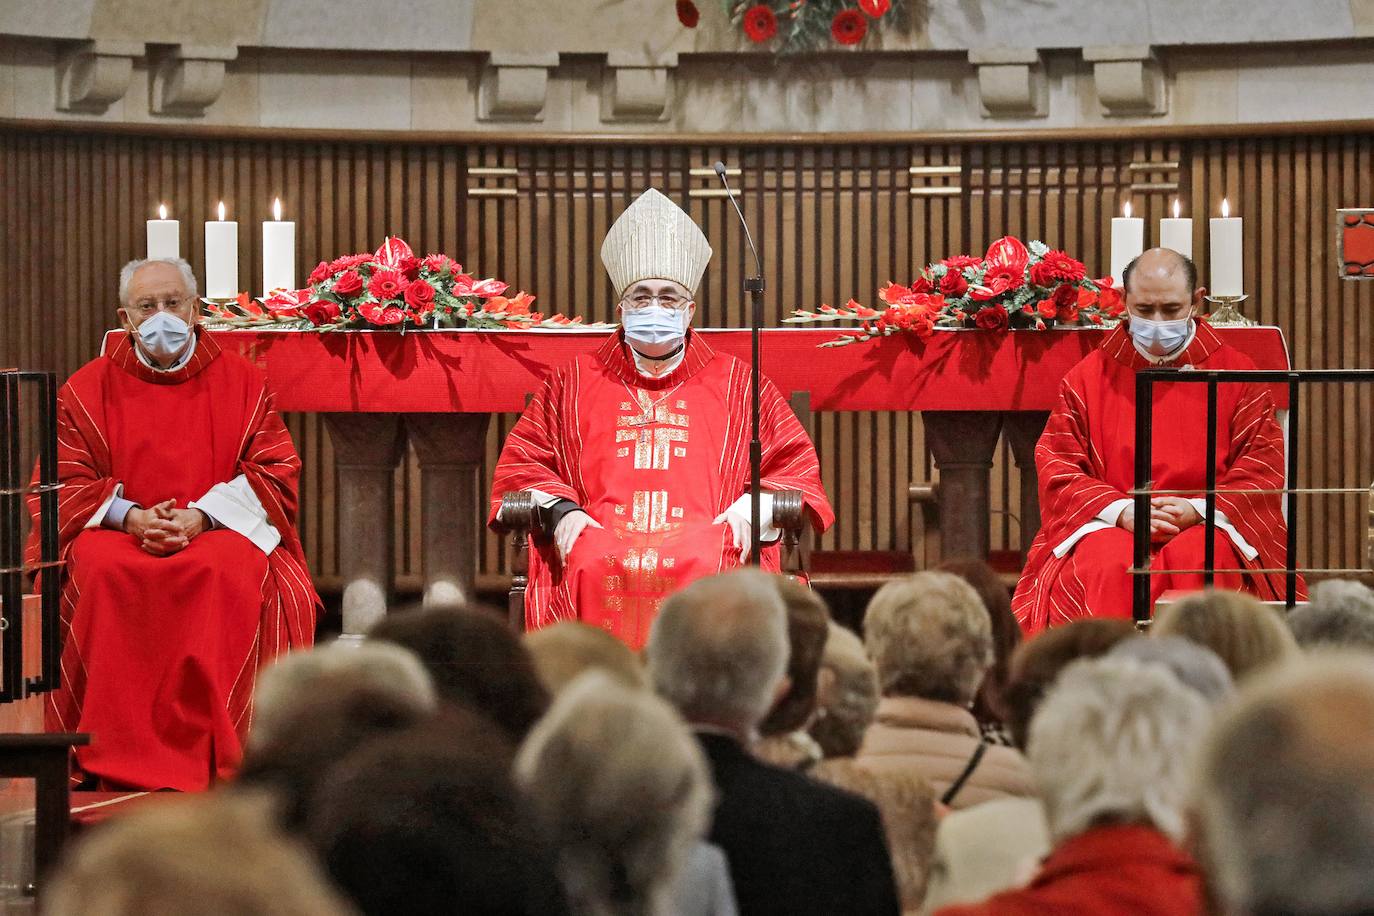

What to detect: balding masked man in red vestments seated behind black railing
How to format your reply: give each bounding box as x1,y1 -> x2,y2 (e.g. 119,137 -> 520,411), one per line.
1013,249 -> 1303,634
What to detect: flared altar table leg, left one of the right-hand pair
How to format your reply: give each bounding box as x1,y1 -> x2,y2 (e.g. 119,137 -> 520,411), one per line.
921,411 -> 1002,560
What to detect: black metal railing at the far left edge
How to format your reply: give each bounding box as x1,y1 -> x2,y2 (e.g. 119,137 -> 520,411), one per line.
0,369 -> 62,703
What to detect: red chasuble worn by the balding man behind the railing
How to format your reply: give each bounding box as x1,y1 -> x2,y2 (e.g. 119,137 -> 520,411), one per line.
1011,321 -> 1305,634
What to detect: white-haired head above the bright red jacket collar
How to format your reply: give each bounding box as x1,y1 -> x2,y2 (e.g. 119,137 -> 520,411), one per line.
1026,658 -> 1210,840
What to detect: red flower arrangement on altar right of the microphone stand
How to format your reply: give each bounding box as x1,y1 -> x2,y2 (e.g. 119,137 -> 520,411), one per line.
785,236 -> 1125,346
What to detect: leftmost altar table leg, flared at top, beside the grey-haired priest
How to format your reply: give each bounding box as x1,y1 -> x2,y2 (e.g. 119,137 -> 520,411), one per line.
324,413 -> 405,636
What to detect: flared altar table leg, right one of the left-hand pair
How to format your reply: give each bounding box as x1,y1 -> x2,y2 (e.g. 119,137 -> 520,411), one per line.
405,413 -> 492,606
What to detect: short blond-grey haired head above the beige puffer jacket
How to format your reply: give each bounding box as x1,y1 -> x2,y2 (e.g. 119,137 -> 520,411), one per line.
863,573 -> 992,706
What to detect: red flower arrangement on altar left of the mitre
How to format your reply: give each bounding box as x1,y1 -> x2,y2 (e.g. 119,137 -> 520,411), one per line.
207,238 -> 610,331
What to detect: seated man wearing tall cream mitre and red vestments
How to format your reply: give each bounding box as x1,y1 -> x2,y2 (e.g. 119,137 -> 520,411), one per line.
491,190 -> 834,650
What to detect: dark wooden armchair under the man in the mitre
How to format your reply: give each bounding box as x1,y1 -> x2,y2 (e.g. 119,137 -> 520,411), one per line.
497,391 -> 811,630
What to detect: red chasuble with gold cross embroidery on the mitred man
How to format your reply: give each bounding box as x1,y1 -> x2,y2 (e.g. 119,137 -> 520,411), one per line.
491,332 -> 834,650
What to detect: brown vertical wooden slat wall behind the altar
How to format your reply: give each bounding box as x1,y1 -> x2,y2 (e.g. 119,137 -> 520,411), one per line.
0,130 -> 1374,580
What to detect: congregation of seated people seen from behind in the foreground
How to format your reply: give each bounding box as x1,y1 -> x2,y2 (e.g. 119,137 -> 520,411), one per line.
43,562 -> 1374,916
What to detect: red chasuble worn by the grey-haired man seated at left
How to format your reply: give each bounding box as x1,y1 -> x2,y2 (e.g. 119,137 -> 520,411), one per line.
29,330 -> 319,790
